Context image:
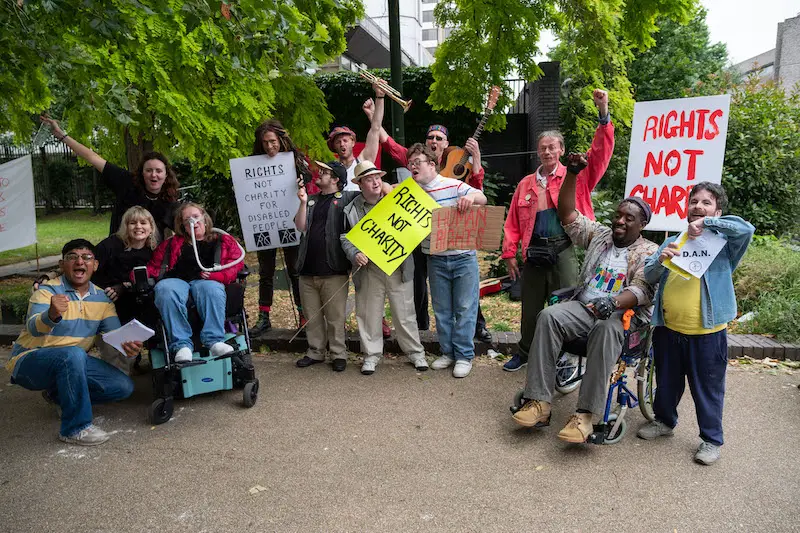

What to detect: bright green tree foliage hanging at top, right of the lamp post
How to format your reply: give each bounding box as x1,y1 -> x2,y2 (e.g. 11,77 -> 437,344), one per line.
429,0 -> 696,127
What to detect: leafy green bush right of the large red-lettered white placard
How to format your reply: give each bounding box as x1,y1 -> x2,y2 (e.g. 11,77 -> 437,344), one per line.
689,76 -> 800,235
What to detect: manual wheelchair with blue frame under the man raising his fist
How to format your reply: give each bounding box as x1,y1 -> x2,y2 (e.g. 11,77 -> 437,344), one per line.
510,287 -> 656,444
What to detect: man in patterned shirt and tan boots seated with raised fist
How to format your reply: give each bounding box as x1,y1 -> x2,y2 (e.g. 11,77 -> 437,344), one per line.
514,155 -> 658,442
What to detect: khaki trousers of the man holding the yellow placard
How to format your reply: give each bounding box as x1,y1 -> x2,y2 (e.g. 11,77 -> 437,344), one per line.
356,263 -> 425,357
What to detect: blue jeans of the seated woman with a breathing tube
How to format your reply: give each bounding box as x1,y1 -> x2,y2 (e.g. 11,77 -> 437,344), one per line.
156,278 -> 225,353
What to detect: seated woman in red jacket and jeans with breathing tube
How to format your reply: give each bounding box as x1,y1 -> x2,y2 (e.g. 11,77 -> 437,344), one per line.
147,203 -> 244,363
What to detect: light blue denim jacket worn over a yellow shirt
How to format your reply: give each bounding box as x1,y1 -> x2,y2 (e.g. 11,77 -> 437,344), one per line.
644,215 -> 755,329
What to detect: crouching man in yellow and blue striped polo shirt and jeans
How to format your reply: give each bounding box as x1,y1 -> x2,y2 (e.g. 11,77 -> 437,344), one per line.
6,239 -> 142,446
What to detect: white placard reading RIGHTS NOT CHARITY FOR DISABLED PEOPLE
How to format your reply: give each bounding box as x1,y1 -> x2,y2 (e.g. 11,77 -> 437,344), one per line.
230,152 -> 300,252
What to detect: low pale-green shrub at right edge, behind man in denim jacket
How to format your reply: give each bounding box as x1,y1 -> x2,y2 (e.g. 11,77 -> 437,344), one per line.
733,236 -> 800,342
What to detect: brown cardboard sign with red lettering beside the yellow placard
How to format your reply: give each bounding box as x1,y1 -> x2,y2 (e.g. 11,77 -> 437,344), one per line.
431,205 -> 506,254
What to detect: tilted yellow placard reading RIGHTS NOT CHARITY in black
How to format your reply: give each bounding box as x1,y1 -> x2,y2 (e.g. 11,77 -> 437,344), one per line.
347,180 -> 439,275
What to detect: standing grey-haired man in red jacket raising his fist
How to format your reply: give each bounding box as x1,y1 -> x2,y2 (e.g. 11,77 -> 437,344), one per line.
502,89 -> 614,372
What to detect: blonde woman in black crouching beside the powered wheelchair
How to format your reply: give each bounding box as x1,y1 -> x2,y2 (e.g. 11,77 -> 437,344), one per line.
92,205 -> 160,324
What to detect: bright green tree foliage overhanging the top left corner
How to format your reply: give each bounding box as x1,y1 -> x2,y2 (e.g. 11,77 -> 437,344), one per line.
0,0 -> 362,171
